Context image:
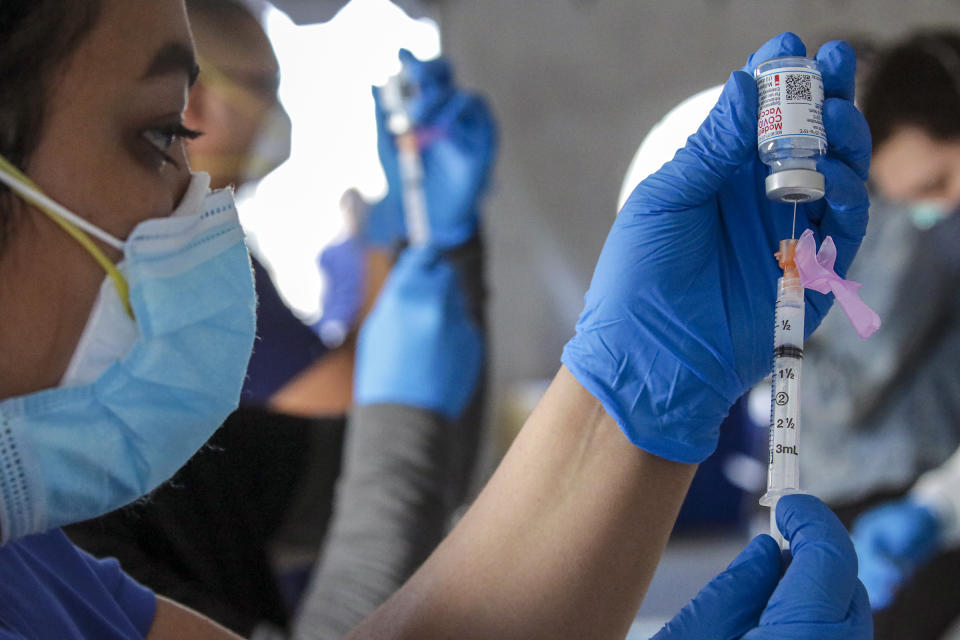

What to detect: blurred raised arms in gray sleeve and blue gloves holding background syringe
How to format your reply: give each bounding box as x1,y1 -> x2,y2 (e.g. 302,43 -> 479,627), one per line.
294,46 -> 497,639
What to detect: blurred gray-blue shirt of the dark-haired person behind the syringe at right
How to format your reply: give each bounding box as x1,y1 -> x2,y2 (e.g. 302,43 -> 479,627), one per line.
800,202 -> 960,503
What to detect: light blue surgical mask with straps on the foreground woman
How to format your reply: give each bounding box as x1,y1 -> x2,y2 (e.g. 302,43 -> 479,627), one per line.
0,159 -> 256,542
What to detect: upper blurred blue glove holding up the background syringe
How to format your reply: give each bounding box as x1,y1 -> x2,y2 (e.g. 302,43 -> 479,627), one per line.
366,50 -> 497,248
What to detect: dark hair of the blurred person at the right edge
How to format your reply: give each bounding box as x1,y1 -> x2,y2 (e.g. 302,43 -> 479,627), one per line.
863,31 -> 960,149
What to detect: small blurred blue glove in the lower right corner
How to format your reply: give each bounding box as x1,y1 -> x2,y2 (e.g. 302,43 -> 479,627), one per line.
853,499 -> 941,609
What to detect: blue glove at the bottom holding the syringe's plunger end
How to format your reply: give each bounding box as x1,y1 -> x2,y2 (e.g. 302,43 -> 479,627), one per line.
652,494 -> 873,640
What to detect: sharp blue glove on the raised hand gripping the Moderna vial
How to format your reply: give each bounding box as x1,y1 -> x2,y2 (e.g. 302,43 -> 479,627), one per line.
563,33 -> 870,463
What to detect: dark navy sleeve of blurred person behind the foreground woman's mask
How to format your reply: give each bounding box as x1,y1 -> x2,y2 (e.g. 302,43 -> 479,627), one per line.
240,259 -> 327,407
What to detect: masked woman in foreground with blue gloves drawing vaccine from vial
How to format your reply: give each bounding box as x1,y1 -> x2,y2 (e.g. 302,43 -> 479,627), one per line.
0,0 -> 870,638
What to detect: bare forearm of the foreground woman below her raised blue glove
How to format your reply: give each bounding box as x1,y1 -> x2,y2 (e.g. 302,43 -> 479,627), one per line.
351,369 -> 695,638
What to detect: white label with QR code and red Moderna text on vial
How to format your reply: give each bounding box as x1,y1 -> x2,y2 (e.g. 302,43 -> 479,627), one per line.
757,67 -> 827,144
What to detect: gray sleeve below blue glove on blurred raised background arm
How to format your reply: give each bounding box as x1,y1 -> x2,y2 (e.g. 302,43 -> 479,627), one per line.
293,240 -> 485,640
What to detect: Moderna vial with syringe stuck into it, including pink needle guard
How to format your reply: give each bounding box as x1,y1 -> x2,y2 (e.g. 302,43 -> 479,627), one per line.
754,57 -> 880,548
